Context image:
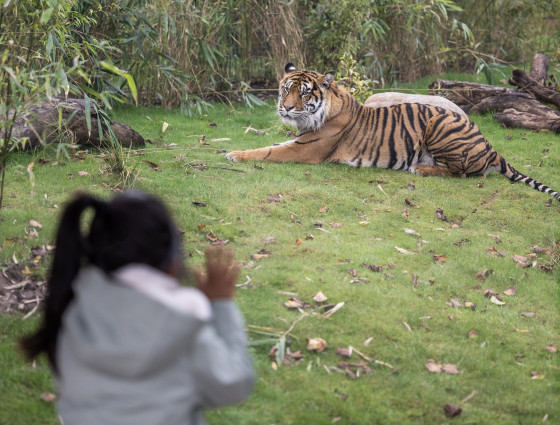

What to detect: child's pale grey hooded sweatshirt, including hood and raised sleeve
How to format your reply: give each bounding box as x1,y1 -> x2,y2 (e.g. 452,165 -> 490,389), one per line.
56,265 -> 254,425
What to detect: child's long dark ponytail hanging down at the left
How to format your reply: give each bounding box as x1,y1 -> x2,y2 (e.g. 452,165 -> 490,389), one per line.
20,195 -> 106,371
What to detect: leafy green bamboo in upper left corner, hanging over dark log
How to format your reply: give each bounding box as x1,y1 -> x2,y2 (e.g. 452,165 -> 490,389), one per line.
0,0 -> 142,208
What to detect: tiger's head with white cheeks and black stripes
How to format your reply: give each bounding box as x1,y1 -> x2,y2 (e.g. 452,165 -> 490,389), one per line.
278,63 -> 334,131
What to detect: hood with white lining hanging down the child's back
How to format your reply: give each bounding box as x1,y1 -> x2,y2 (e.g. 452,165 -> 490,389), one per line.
58,265 -> 212,379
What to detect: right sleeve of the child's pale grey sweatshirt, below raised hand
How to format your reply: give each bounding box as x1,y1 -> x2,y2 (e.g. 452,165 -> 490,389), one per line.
194,300 -> 255,407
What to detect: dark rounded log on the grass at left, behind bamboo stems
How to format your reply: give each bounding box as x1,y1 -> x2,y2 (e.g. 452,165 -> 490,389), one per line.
0,98 -> 145,149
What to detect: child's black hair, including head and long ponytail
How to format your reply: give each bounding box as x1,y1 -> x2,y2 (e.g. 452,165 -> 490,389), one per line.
20,191 -> 181,372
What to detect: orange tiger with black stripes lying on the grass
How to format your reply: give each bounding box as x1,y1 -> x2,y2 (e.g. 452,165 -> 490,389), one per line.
226,63 -> 560,201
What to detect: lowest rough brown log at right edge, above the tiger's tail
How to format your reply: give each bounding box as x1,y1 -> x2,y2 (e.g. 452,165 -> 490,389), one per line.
469,92 -> 560,119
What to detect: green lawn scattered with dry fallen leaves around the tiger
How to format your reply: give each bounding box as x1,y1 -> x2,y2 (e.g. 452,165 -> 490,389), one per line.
0,87 -> 560,425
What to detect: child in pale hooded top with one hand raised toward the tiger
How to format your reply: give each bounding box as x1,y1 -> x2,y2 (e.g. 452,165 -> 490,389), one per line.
21,192 -> 254,425
